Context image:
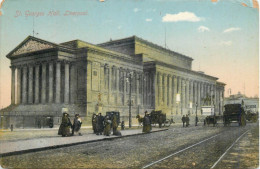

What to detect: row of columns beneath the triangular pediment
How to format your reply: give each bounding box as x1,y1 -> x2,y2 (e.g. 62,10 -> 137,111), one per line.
11,61 -> 76,104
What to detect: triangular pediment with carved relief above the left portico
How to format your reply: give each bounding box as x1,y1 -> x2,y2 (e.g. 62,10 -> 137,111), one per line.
7,36 -> 57,57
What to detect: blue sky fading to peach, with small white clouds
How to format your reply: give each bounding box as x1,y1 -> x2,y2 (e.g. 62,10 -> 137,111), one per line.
0,0 -> 259,108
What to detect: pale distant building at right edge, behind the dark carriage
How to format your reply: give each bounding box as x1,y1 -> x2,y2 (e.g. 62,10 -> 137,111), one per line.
224,92 -> 259,113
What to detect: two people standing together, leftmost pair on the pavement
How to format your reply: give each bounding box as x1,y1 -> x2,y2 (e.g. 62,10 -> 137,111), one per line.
58,113 -> 82,137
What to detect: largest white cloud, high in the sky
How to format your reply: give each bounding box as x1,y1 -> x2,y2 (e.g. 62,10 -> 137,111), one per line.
162,12 -> 203,22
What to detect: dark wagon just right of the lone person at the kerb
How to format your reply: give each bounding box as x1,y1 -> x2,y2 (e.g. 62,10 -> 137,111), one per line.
151,110 -> 171,127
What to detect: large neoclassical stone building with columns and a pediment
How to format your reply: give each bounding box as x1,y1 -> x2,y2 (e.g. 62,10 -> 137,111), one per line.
3,36 -> 225,125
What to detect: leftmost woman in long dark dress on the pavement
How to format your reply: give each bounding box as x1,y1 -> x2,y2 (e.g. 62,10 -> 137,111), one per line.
58,113 -> 72,137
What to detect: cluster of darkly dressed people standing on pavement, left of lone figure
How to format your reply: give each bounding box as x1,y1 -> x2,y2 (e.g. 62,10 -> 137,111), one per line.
92,113 -> 121,136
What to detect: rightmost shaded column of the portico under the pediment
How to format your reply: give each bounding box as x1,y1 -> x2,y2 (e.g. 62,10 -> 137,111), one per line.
70,64 -> 77,103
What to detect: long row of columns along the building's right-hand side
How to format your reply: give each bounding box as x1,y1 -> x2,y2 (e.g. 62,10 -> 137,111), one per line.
155,72 -> 224,114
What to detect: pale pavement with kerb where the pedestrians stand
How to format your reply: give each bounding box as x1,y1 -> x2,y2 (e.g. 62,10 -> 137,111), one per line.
0,127 -> 168,157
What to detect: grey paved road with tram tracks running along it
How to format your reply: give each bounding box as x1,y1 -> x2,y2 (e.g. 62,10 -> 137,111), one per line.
0,124 -> 259,168
